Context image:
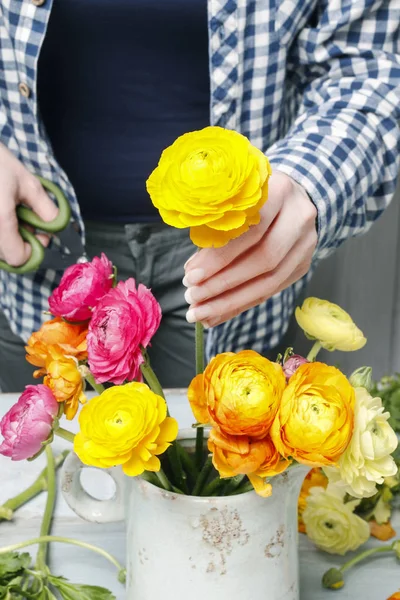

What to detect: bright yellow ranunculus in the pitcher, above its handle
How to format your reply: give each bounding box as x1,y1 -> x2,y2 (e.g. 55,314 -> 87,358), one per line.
74,382 -> 178,476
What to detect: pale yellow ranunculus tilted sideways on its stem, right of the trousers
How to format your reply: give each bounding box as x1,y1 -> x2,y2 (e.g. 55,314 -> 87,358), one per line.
295,298 -> 367,352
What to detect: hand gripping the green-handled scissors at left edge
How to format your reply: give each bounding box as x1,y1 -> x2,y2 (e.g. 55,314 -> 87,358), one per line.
0,144 -> 58,267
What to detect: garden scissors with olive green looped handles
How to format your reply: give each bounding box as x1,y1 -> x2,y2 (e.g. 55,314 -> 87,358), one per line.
0,177 -> 87,275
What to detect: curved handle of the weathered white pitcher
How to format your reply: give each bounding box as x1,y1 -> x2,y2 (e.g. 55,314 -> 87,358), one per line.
61,452 -> 125,523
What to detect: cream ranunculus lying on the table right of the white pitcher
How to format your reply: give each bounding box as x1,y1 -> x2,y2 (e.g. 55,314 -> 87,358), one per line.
303,484 -> 370,555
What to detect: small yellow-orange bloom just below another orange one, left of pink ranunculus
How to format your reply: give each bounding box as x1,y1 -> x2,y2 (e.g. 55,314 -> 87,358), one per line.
43,346 -> 86,420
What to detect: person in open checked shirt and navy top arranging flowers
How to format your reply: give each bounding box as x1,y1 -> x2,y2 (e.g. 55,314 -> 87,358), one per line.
0,0 -> 400,391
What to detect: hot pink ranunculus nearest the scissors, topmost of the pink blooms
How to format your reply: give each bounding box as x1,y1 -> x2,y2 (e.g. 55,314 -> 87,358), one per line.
49,253 -> 113,321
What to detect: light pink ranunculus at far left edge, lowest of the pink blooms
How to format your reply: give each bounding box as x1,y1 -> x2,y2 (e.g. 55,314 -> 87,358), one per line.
0,384 -> 59,460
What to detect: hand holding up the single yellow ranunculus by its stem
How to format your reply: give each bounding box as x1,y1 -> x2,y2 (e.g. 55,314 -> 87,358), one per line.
183,172 -> 317,327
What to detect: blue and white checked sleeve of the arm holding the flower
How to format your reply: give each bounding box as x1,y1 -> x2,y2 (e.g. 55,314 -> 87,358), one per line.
267,0 -> 400,259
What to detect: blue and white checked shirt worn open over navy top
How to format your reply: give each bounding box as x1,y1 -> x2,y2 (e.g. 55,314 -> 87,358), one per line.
0,0 -> 400,353
